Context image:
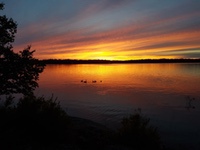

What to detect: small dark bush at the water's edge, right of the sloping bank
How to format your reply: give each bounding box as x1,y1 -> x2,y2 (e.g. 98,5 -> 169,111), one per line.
118,109 -> 161,150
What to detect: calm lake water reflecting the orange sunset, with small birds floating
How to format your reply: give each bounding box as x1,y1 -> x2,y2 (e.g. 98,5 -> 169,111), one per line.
35,63 -> 200,149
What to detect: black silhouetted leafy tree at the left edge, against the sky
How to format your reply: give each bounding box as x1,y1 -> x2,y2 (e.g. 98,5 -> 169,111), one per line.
0,3 -> 44,95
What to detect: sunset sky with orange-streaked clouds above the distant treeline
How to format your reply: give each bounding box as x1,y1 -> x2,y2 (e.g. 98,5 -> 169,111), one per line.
0,0 -> 200,60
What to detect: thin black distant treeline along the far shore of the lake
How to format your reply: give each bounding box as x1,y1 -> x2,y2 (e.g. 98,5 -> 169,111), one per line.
41,59 -> 200,64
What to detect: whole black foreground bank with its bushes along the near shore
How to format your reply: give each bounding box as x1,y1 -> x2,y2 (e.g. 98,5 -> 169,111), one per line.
0,95 -> 163,150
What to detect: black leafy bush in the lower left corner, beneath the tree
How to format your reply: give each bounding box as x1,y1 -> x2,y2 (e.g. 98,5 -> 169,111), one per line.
0,96 -> 70,149
